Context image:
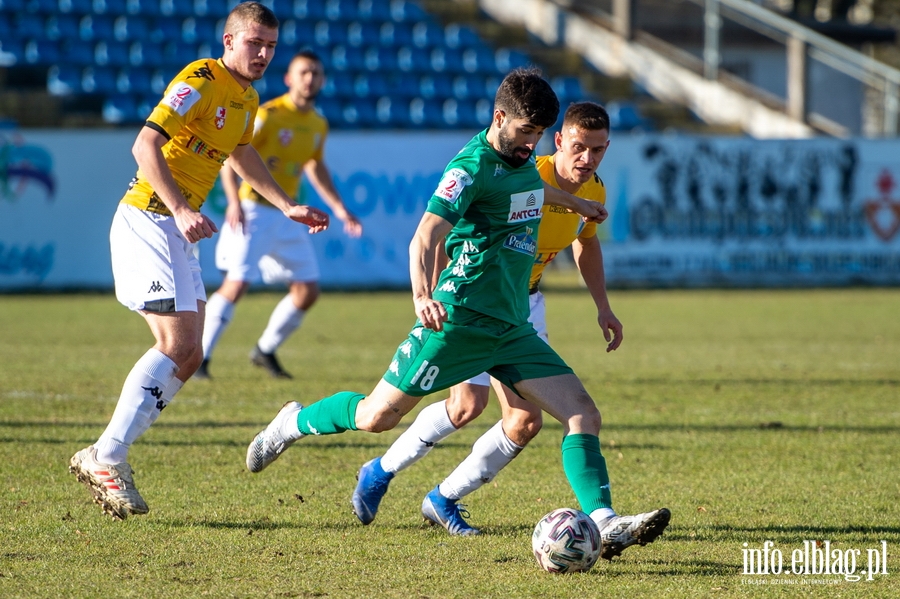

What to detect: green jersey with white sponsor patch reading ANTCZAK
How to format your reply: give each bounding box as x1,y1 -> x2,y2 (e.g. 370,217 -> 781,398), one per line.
426,131 -> 544,325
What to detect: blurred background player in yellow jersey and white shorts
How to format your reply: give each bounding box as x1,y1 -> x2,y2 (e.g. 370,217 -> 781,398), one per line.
200,50 -> 362,378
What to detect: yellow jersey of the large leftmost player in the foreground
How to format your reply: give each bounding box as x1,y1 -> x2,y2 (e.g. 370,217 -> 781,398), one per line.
122,59 -> 259,215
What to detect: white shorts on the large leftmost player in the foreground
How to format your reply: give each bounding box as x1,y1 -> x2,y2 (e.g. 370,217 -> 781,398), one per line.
109,204 -> 206,312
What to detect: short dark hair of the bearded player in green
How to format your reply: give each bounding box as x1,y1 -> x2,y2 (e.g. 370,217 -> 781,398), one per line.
494,67 -> 559,128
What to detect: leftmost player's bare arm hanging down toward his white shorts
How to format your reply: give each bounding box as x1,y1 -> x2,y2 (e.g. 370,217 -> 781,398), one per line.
131,127 -> 218,243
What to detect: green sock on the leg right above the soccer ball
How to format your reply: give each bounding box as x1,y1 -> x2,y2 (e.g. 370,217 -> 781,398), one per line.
564,434 -> 612,514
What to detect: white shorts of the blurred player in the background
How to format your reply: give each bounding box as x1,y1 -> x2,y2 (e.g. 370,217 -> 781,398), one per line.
216,200 -> 319,284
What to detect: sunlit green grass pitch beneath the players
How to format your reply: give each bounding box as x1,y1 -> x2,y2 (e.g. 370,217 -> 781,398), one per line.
0,281 -> 900,598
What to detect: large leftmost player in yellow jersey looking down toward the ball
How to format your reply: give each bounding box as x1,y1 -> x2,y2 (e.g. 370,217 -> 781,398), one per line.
69,2 -> 328,520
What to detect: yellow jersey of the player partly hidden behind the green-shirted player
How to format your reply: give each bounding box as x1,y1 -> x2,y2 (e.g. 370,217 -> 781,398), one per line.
528,155 -> 606,291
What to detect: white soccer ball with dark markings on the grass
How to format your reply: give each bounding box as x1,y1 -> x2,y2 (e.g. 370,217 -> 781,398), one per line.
531,507 -> 600,574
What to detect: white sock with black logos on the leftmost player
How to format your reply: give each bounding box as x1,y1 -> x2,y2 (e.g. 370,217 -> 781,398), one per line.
94,349 -> 178,464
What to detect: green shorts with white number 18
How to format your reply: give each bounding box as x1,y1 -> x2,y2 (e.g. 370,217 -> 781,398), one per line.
384,304 -> 572,397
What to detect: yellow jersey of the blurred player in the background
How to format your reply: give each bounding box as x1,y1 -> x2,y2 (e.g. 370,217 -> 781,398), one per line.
238,94 -> 328,204
